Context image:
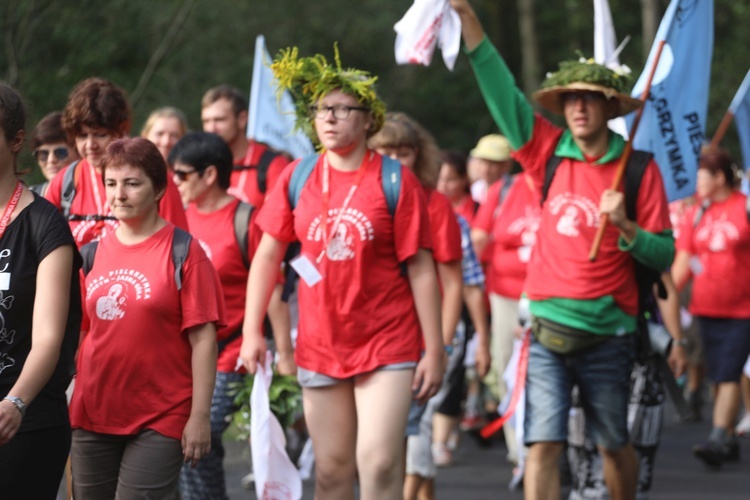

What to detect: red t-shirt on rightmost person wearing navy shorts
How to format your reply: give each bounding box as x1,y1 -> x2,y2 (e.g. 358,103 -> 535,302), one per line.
676,191 -> 750,318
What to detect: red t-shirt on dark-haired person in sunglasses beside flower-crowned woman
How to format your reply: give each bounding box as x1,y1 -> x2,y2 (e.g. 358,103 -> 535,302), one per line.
186,199 -> 261,373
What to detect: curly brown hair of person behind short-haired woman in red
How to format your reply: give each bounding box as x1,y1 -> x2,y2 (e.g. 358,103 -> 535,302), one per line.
62,78 -> 132,141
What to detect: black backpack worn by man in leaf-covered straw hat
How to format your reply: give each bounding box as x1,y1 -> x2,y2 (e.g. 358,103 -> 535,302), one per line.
542,150 -> 667,329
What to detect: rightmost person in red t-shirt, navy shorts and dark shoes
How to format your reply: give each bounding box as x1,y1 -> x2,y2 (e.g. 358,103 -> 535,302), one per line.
672,150 -> 750,466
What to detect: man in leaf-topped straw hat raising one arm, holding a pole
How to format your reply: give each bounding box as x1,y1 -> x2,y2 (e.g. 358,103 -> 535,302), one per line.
450,0 -> 674,499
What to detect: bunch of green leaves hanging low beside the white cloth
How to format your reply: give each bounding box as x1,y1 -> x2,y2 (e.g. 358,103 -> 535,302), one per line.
229,372 -> 302,441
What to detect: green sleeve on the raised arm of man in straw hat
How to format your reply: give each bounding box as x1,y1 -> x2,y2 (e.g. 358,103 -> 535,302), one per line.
467,36 -> 534,150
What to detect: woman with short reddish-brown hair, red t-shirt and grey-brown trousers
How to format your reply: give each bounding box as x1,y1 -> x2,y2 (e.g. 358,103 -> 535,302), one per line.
70,137 -> 224,498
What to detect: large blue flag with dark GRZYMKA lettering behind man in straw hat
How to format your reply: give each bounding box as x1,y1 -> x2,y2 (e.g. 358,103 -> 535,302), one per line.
627,0 -> 714,201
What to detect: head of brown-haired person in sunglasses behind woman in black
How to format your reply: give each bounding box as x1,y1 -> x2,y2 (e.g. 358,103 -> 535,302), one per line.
29,111 -> 78,196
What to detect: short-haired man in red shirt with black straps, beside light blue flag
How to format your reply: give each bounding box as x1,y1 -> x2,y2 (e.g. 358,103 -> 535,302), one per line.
201,85 -> 289,208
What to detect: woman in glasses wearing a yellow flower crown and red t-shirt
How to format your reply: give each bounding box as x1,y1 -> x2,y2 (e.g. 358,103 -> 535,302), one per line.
240,48 -> 443,499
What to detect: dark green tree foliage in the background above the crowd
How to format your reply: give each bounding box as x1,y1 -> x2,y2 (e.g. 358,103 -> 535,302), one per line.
5,0 -> 750,180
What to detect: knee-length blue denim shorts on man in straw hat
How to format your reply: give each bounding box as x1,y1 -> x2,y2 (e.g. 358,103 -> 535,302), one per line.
524,335 -> 635,450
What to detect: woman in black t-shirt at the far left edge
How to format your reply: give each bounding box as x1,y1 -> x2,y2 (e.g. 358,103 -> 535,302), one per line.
0,84 -> 80,499
